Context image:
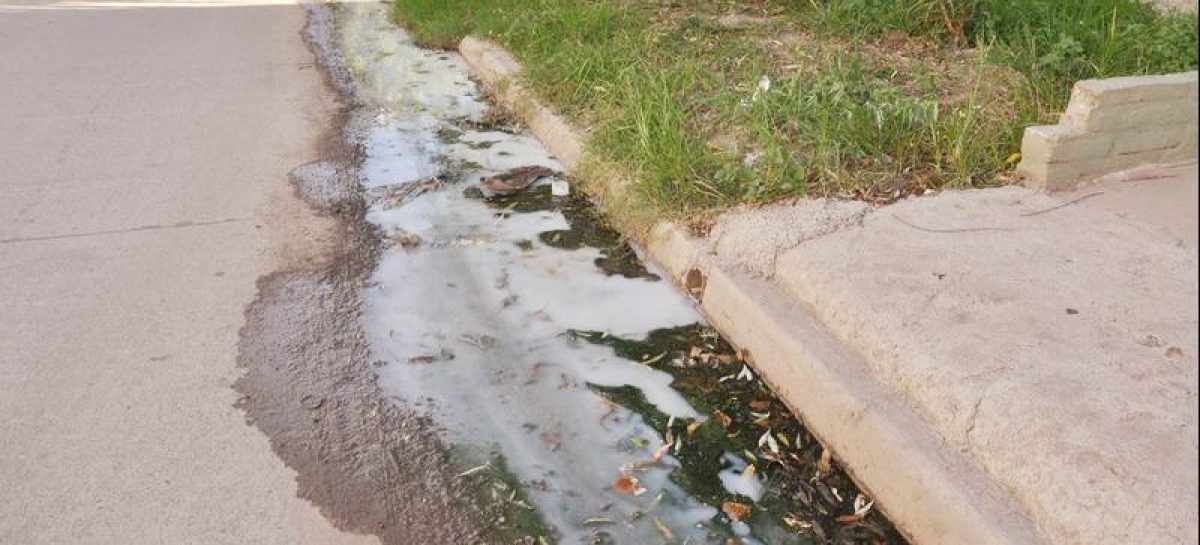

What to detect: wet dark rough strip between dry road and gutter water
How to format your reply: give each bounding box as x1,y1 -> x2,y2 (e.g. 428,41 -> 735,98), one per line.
233,7 -> 480,544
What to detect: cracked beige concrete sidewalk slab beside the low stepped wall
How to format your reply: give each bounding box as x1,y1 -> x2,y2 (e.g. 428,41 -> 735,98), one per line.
674,171 -> 1198,545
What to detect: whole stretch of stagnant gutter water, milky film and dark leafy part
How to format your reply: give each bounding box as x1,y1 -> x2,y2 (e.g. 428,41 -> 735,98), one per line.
336,4 -> 899,545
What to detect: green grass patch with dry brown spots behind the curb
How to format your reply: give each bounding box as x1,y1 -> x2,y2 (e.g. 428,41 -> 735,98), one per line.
394,0 -> 1196,220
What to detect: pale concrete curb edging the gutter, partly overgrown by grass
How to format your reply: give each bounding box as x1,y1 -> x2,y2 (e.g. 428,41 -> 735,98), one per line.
460,37 -> 1046,545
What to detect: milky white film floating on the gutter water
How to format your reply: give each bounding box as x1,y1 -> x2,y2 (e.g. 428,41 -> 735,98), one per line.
337,4 -> 761,544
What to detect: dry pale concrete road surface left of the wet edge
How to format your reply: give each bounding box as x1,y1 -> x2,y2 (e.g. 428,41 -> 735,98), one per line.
0,0 -> 374,544
